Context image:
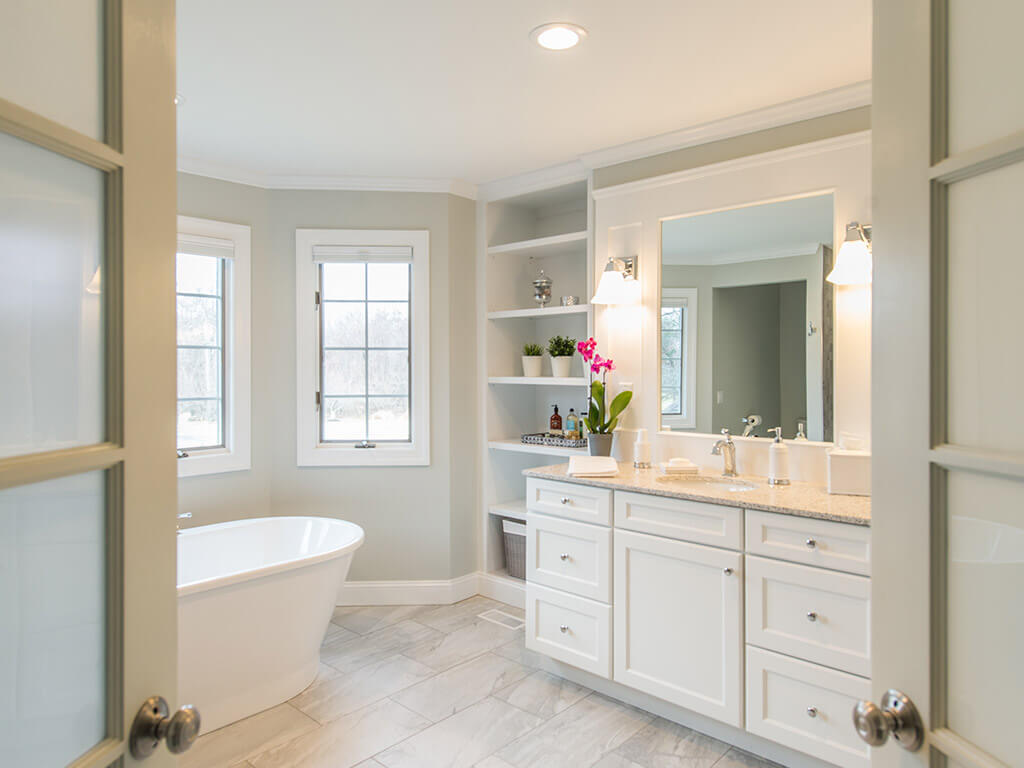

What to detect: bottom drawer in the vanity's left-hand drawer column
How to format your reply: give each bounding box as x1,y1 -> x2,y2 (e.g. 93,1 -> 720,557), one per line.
526,584 -> 611,678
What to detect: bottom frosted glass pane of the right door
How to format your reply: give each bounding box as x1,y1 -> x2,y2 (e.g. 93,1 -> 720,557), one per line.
946,472 -> 1024,765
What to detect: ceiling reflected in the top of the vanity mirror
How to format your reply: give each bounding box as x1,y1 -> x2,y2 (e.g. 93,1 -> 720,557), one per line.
662,194 -> 833,265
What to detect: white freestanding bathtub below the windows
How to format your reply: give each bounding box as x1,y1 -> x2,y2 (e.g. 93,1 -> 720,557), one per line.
178,517 -> 364,733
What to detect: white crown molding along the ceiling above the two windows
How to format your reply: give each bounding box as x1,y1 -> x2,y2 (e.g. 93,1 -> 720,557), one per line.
177,158 -> 476,200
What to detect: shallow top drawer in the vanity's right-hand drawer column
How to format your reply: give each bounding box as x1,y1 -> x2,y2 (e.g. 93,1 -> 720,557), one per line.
746,510 -> 871,575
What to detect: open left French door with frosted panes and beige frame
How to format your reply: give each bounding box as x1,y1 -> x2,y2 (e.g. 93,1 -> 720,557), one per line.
0,0 -> 177,768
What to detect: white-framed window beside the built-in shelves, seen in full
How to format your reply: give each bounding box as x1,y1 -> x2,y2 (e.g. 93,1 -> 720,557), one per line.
296,229 -> 430,466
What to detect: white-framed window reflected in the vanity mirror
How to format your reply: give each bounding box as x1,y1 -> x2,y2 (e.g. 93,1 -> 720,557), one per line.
662,288 -> 697,429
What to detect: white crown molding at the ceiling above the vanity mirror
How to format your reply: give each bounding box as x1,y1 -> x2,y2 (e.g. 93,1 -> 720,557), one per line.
580,80 -> 871,169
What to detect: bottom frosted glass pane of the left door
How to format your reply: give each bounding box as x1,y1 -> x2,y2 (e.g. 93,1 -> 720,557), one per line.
0,472 -> 106,768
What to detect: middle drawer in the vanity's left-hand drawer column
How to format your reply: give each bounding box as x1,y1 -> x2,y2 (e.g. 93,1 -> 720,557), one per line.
526,512 -> 611,603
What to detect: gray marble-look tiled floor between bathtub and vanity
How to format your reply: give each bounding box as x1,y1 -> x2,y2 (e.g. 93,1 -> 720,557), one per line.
181,597 -> 772,768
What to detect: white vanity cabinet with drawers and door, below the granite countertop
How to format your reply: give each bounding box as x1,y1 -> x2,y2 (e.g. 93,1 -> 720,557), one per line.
526,477 -> 870,768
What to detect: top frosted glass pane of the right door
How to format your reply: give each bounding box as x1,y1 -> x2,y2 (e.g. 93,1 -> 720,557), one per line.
947,0 -> 1024,154
